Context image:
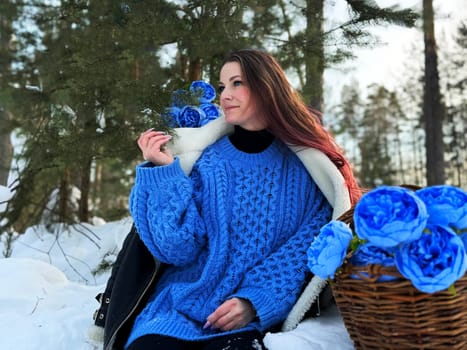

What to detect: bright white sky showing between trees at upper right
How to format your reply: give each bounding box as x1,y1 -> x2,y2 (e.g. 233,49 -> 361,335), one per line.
324,0 -> 467,107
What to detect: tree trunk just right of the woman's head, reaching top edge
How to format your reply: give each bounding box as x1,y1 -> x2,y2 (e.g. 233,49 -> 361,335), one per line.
302,0 -> 324,111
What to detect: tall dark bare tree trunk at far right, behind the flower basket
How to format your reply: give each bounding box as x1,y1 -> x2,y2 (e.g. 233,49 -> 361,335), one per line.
423,0 -> 444,186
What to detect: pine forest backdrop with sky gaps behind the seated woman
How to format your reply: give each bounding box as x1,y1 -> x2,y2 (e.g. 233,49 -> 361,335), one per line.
0,0 -> 467,234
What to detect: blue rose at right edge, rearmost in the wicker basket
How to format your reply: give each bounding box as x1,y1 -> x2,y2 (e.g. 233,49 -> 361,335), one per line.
415,185 -> 467,229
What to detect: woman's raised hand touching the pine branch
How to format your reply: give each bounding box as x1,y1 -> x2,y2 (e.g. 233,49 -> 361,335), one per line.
138,129 -> 174,165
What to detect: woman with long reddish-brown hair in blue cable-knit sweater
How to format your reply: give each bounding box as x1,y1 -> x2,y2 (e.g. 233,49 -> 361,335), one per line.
92,50 -> 359,349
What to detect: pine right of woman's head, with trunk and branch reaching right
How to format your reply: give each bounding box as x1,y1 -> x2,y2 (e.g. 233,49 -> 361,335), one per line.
277,0 -> 418,110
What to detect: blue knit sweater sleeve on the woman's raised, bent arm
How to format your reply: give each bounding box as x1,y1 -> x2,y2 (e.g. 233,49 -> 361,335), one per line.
129,158 -> 206,266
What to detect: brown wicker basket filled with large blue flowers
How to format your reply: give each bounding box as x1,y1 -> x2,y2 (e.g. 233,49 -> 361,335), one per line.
308,185 -> 467,350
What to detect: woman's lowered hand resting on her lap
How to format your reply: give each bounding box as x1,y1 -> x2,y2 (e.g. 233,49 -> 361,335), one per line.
204,298 -> 256,331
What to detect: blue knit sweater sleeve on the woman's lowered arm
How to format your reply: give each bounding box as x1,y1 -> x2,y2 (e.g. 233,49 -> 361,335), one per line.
232,185 -> 332,330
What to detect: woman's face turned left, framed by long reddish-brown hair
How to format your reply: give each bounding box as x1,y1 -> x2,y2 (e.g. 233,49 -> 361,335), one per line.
219,62 -> 266,130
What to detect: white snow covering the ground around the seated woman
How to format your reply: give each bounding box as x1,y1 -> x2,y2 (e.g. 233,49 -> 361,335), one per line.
0,186 -> 353,350
